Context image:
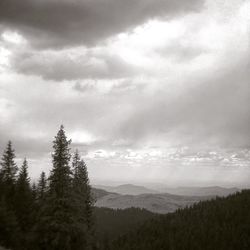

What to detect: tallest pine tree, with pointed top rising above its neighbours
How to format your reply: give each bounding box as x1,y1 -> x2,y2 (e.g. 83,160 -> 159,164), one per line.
38,126 -> 77,250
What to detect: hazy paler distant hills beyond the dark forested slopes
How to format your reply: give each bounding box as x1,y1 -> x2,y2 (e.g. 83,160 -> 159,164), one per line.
92,184 -> 238,214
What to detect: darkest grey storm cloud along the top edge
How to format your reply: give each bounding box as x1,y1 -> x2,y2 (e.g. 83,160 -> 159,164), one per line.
0,0 -> 203,48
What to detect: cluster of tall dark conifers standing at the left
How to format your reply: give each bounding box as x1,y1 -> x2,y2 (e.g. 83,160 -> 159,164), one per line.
0,126 -> 96,250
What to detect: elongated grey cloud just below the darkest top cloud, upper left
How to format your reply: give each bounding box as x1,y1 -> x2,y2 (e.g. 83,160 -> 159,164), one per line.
11,51 -> 136,81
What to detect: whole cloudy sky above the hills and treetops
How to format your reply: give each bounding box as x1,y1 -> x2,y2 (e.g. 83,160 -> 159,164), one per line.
0,0 -> 250,186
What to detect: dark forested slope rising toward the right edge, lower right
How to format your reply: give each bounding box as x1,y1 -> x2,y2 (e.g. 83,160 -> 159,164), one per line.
112,190 -> 250,250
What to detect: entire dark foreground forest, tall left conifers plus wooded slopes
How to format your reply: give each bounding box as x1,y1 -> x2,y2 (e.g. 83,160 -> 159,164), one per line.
0,126 -> 250,250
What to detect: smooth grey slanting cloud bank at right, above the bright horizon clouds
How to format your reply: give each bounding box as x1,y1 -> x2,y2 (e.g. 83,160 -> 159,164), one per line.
117,55 -> 250,147
